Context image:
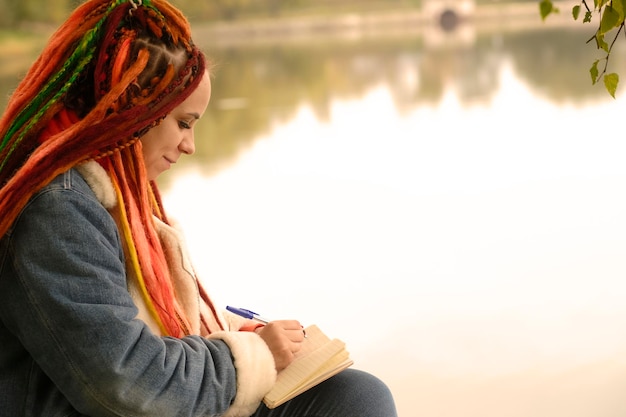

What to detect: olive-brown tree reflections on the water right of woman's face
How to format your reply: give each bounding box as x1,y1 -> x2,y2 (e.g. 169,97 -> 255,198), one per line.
149,23 -> 624,183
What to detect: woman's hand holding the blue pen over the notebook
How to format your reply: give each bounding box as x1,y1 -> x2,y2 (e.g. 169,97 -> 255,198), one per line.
255,320 -> 304,372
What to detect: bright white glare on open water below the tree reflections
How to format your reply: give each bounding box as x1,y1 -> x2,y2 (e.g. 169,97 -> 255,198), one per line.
167,66 -> 626,417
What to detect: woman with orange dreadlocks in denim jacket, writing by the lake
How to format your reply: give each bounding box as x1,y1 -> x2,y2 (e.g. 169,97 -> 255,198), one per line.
0,0 -> 396,417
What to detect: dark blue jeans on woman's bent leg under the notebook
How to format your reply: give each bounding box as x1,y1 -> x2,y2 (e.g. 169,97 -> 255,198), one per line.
251,368 -> 398,417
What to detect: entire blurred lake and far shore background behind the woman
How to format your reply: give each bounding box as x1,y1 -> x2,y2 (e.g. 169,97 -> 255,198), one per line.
0,0 -> 626,417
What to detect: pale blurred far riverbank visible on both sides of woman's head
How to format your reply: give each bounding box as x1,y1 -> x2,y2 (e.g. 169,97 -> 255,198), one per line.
0,1 -> 582,67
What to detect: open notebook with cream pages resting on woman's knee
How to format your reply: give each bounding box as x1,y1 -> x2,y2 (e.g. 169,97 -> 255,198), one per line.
263,325 -> 354,408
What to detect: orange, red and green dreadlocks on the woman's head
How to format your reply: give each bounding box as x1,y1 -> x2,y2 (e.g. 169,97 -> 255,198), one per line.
0,0 -> 210,337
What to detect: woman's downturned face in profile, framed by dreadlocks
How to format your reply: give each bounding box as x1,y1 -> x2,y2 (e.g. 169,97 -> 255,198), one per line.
141,73 -> 211,180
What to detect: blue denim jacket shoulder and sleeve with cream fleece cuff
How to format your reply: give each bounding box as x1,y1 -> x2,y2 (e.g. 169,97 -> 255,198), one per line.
0,162 -> 275,417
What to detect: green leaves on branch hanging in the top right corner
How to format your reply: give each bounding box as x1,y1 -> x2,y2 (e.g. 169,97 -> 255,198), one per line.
539,0 -> 626,98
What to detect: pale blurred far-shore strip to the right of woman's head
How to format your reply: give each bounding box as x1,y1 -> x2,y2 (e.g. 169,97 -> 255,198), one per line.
192,2 -> 582,46
